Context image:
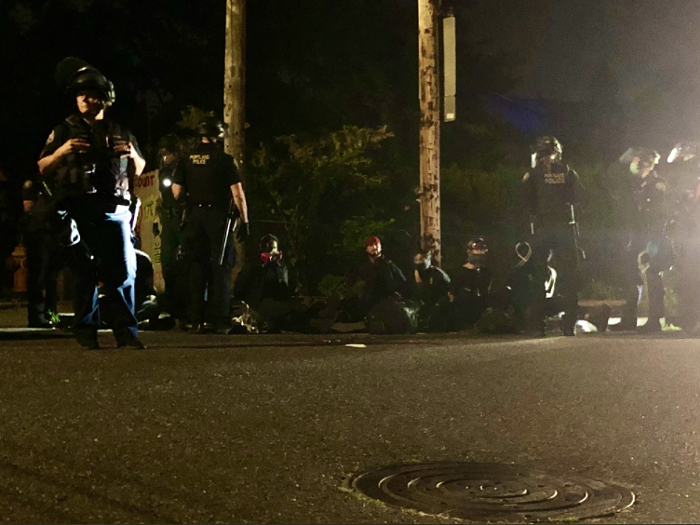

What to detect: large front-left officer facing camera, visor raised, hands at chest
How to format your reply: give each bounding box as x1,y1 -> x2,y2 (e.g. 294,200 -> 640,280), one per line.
38,57 -> 146,349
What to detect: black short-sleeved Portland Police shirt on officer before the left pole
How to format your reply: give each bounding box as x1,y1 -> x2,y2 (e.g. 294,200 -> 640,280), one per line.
173,142 -> 241,208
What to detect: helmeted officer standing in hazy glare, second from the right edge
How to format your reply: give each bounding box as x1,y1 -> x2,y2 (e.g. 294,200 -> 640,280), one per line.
620,148 -> 673,333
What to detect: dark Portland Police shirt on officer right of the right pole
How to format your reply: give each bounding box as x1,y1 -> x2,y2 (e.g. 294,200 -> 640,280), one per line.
523,164 -> 579,224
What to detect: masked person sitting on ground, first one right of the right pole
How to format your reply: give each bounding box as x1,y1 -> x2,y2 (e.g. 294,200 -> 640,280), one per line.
449,237 -> 493,330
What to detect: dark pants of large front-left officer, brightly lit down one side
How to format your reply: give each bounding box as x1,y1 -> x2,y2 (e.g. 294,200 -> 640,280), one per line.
69,199 -> 138,343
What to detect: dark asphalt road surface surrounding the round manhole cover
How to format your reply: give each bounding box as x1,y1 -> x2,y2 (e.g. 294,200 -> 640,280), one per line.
0,330 -> 700,523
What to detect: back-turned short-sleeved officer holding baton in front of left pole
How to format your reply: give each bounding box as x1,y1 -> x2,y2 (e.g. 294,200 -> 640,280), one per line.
172,117 -> 250,334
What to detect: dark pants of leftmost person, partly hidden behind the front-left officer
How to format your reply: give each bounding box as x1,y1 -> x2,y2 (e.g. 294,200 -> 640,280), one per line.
24,224 -> 63,325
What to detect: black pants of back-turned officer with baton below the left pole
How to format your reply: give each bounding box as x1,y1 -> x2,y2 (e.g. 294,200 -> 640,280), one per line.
183,207 -> 236,324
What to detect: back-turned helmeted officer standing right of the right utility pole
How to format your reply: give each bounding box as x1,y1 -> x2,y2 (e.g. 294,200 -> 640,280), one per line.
522,136 -> 580,336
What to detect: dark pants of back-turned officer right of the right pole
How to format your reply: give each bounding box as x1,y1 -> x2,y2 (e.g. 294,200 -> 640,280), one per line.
529,227 -> 579,331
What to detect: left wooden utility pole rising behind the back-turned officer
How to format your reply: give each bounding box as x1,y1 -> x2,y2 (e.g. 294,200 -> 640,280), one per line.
224,0 -> 245,171
